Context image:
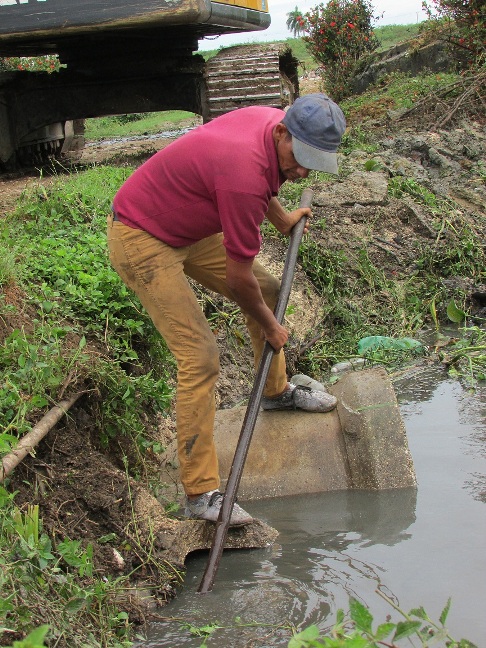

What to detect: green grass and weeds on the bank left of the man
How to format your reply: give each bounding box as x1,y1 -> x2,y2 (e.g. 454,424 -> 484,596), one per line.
0,167 -> 173,451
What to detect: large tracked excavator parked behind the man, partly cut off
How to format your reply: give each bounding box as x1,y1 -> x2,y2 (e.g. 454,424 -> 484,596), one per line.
0,0 -> 299,170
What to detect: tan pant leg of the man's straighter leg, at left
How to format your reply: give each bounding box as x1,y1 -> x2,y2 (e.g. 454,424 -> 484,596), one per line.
108,219 -> 220,495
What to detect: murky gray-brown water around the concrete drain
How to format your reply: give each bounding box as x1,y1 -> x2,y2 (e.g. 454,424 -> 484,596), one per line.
140,370 -> 486,648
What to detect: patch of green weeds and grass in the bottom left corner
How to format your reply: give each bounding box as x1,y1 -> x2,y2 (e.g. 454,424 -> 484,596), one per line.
0,486 -> 131,648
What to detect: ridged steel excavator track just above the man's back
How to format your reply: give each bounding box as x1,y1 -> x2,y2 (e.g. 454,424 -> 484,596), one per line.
203,44 -> 299,121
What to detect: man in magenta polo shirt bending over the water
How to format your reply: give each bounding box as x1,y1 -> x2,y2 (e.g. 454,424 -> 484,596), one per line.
108,94 -> 346,525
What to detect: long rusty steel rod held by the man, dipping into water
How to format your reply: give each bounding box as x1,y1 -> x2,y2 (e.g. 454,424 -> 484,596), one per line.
198,189 -> 312,594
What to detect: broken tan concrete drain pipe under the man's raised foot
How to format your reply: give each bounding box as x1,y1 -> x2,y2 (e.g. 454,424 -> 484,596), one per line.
214,367 -> 416,501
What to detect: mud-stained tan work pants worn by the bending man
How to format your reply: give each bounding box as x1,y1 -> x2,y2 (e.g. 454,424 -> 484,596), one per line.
108,215 -> 287,495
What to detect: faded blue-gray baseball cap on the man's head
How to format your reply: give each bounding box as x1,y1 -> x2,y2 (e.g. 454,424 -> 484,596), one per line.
282,92 -> 346,174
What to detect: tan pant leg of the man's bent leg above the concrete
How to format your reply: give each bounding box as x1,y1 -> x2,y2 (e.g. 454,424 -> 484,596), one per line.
184,234 -> 287,397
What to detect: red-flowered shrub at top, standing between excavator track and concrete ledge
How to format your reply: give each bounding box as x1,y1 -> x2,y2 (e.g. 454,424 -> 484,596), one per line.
293,0 -> 379,100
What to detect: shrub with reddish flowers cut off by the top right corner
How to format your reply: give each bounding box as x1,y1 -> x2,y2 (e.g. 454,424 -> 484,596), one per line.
422,0 -> 486,61
